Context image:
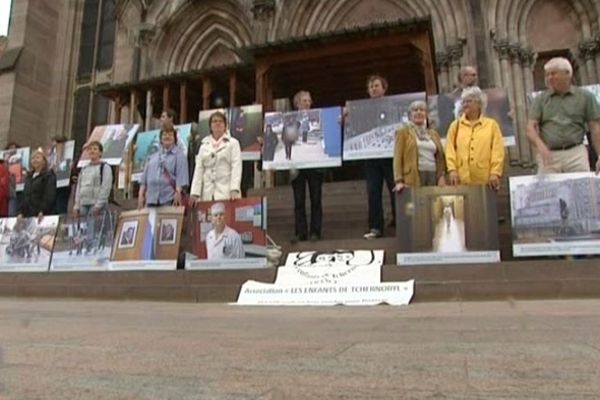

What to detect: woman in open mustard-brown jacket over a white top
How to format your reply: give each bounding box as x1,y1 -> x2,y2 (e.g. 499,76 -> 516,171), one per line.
394,101 -> 446,192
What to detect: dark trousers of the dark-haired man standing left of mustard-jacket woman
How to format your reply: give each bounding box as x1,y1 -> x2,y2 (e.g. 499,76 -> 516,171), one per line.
365,158 -> 396,232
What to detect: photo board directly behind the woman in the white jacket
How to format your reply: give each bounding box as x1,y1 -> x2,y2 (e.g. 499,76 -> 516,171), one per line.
198,104 -> 263,160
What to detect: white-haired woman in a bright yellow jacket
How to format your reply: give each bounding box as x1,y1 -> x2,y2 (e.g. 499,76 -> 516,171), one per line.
446,86 -> 504,190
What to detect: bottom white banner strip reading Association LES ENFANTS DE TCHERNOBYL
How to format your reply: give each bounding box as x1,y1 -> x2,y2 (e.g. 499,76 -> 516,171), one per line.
237,280 -> 415,306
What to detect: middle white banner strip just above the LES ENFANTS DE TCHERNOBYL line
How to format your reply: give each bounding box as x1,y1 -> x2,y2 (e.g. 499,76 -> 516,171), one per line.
275,265 -> 381,285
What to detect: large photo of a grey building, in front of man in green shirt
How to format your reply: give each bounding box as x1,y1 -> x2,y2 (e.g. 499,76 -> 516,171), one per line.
510,172 -> 600,257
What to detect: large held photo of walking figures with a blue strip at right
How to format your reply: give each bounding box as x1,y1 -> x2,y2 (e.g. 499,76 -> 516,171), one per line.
263,107 -> 342,170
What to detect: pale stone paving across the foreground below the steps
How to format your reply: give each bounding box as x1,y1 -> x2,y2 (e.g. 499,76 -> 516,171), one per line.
0,299 -> 600,400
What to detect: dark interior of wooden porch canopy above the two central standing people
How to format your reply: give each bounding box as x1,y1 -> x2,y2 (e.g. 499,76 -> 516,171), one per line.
245,18 -> 438,110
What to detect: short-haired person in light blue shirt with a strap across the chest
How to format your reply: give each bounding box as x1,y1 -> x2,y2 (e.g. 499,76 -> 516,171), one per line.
138,110 -> 189,209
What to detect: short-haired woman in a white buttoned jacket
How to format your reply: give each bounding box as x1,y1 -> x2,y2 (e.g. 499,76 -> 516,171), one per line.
190,111 -> 242,202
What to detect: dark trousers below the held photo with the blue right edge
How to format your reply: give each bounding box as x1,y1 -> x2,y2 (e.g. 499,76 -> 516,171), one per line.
292,169 -> 323,239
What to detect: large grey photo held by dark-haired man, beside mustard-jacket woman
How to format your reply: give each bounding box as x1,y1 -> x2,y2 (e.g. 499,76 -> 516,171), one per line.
344,92 -> 425,160
